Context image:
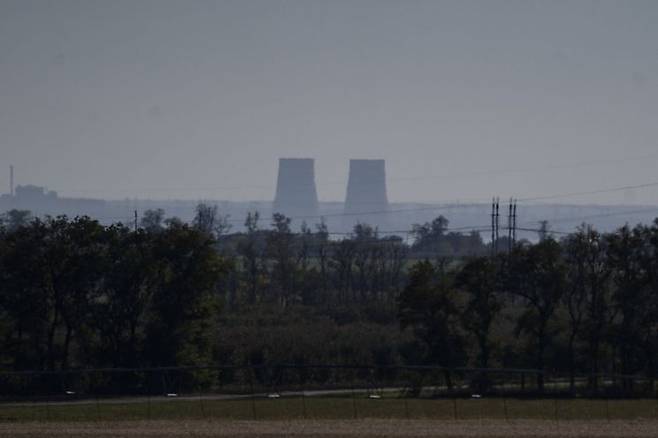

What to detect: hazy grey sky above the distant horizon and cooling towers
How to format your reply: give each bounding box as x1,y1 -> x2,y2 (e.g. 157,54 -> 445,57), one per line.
0,0 -> 658,204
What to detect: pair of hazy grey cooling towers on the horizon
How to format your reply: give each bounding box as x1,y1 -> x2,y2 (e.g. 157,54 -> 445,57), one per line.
273,158 -> 388,222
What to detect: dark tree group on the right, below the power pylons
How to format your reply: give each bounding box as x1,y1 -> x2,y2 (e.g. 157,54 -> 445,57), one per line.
399,226 -> 658,388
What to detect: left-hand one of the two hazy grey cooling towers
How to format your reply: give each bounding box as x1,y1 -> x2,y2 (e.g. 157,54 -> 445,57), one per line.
273,158 -> 318,222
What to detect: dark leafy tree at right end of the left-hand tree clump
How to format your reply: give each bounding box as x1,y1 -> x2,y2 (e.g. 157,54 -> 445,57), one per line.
145,221 -> 226,366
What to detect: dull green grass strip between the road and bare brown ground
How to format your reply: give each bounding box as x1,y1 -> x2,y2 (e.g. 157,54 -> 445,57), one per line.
0,396 -> 658,422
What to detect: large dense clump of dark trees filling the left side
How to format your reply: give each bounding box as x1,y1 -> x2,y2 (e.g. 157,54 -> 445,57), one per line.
0,217 -> 227,369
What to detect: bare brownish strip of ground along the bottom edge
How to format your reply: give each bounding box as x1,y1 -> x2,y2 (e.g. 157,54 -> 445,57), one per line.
0,419 -> 658,438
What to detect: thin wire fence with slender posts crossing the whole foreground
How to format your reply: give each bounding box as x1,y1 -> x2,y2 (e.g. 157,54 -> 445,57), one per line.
0,365 -> 658,421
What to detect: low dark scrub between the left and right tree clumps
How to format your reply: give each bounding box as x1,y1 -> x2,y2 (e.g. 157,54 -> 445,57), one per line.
217,305 -> 404,365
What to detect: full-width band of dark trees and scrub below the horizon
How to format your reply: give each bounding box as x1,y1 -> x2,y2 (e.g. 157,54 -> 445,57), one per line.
0,204 -> 658,394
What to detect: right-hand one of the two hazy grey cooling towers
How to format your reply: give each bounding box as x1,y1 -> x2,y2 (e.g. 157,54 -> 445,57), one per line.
344,160 -> 388,227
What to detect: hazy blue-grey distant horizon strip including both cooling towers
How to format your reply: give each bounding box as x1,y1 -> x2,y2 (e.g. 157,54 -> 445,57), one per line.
0,159 -> 655,240
